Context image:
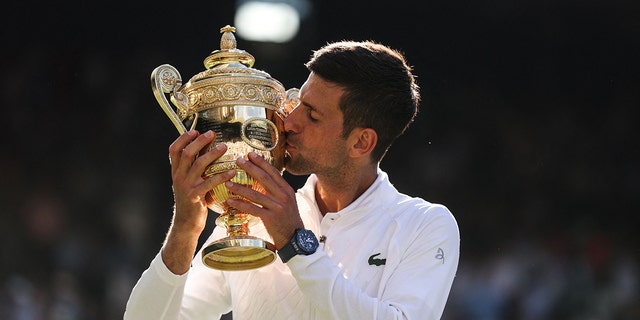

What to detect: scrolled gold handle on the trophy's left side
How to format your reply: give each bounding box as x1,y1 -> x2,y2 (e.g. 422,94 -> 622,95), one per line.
151,64 -> 188,134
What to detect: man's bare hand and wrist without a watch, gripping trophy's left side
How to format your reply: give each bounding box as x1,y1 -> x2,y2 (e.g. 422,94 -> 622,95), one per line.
162,130 -> 235,274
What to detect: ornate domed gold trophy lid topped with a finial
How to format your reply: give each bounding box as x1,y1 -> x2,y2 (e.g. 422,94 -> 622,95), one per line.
171,25 -> 285,120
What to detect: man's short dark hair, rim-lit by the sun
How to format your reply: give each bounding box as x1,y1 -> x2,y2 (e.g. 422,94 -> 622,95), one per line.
305,41 -> 420,161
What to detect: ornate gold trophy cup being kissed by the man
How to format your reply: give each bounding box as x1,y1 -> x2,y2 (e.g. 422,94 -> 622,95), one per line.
151,26 -> 298,270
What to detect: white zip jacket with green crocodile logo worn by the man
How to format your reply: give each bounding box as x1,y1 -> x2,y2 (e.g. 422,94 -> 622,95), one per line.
125,169 -> 460,320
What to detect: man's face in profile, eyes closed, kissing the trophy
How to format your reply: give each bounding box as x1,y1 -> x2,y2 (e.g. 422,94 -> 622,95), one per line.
284,73 -> 347,175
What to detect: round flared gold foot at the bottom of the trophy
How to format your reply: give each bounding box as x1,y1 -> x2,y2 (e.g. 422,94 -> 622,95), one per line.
202,236 -> 276,271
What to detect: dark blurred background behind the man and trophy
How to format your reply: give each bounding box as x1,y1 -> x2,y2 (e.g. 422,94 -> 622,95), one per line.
0,0 -> 640,320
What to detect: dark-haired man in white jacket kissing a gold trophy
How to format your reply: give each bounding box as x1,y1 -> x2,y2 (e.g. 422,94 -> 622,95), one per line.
125,41 -> 460,320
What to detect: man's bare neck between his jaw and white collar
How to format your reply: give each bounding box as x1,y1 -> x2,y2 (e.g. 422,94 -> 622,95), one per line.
315,165 -> 378,216
